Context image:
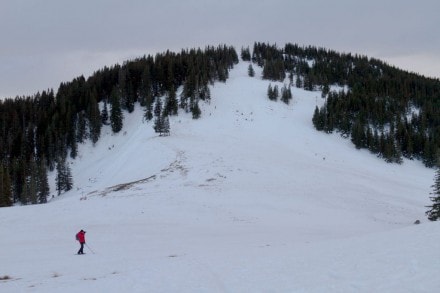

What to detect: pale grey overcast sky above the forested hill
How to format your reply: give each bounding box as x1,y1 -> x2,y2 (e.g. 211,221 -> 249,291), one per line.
0,0 -> 440,97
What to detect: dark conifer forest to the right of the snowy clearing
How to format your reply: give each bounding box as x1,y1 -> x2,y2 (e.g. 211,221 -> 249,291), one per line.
251,43 -> 440,167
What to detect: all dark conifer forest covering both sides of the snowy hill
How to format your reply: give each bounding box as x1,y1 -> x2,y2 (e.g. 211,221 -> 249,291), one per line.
0,42 -> 440,207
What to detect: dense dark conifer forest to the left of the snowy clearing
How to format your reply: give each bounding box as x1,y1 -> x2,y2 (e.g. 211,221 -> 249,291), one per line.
0,45 -> 238,207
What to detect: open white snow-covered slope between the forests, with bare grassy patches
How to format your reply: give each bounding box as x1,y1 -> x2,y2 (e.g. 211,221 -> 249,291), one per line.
0,62 -> 440,292
